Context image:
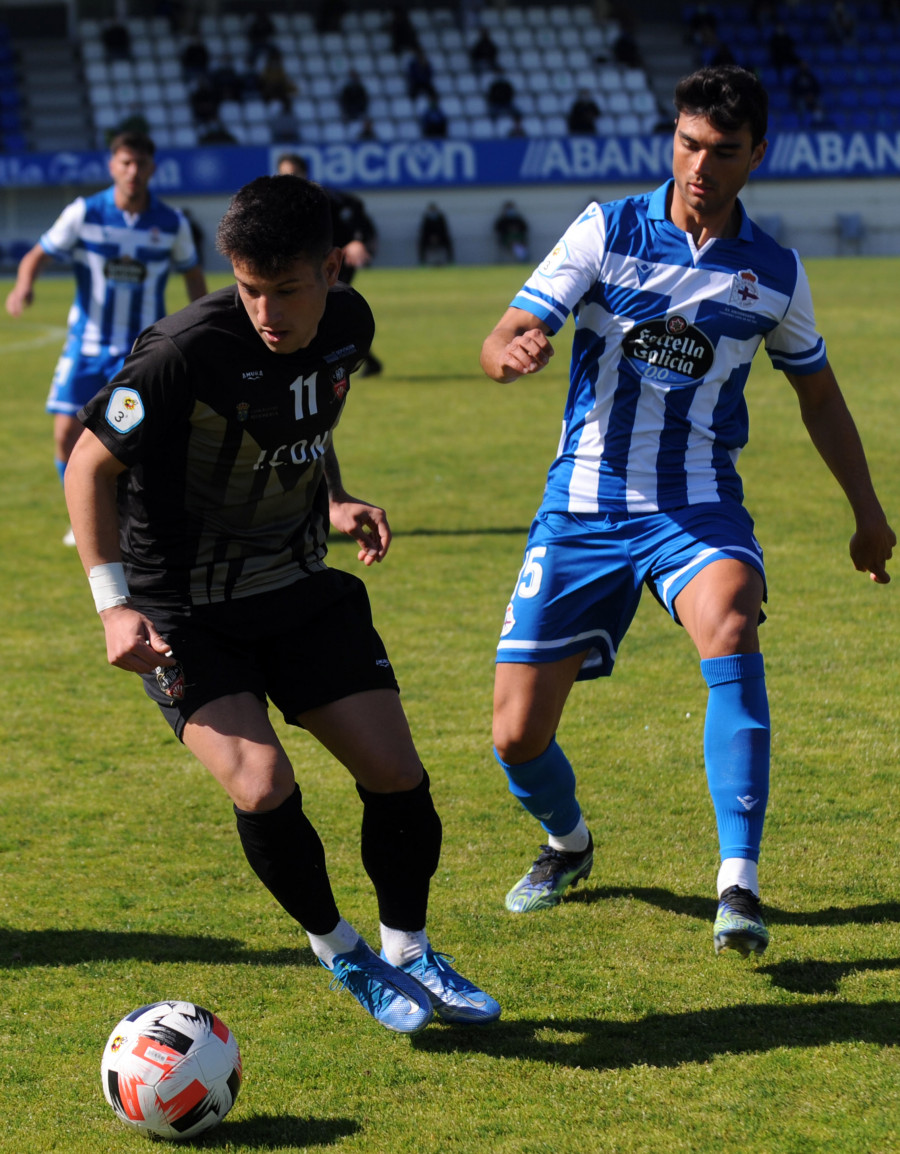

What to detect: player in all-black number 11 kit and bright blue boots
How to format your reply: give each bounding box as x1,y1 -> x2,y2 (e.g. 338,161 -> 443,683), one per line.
66,175 -> 500,1033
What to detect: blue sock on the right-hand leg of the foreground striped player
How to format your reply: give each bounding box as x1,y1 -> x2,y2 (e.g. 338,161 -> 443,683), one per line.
700,653 -> 770,862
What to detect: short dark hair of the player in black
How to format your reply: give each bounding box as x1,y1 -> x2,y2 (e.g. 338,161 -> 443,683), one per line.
216,175 -> 335,276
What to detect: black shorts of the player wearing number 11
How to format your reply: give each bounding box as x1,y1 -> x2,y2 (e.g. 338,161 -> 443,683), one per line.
135,569 -> 398,739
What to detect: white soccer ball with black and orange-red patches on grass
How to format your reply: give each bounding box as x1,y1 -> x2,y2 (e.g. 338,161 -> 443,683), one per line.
100,1002 -> 241,1140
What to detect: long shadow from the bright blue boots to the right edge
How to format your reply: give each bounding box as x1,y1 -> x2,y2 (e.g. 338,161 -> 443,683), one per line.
412,1002 -> 899,1070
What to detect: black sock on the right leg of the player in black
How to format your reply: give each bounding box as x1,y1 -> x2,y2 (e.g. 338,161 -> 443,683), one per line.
357,773 -> 441,931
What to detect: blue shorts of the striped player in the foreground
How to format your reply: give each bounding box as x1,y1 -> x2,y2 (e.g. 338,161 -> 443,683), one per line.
497,503 -> 765,681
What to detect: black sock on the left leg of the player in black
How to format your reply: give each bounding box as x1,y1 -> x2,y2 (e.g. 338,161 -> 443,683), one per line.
234,785 -> 340,934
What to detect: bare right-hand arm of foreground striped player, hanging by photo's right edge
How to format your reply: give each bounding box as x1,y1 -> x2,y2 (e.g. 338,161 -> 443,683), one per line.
787,365 -> 897,585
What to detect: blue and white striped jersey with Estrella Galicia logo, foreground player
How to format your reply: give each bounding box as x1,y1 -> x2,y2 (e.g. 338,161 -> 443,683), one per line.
512,181 -> 826,512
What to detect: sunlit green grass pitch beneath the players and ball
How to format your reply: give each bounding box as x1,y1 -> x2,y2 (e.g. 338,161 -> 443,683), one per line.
0,260 -> 900,1154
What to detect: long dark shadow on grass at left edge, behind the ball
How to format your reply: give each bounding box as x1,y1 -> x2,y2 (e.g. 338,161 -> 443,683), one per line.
0,926 -> 318,968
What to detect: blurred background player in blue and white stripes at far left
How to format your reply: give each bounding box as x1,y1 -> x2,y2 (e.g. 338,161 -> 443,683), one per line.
6,133 -> 207,545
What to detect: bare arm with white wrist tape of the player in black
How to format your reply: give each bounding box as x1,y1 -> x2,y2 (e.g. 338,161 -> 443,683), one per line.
66,429 -> 175,673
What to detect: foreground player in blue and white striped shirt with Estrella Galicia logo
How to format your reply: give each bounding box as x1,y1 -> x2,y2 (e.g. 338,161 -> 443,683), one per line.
481,66 -> 897,957
